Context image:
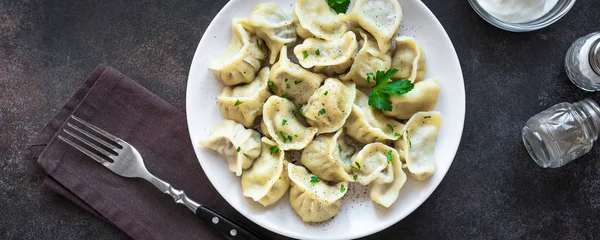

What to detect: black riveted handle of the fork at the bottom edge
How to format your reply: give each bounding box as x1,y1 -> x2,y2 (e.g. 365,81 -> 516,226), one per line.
196,206 -> 260,240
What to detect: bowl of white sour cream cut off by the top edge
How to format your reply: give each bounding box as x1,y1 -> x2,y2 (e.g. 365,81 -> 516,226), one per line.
469,0 -> 575,32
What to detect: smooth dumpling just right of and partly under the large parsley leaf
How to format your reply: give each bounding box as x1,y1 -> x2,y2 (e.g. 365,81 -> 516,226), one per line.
383,78 -> 440,120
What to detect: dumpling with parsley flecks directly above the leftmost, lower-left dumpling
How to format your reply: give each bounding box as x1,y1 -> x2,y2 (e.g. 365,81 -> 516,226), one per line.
217,67 -> 271,128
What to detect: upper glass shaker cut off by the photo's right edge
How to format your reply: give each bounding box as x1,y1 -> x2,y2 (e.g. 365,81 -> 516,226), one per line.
565,32 -> 600,92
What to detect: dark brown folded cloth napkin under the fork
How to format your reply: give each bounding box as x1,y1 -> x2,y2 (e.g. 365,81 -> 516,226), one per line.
28,65 -> 282,239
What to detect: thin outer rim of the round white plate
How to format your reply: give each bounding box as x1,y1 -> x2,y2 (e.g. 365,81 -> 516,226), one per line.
186,0 -> 466,239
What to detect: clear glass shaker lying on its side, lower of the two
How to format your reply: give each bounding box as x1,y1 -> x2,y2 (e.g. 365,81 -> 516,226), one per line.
521,99 -> 600,168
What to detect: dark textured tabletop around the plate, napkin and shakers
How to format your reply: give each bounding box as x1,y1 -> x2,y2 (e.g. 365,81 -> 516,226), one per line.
0,0 -> 600,239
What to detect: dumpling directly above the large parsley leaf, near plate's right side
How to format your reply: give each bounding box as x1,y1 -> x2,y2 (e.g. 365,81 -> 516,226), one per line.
392,36 -> 427,82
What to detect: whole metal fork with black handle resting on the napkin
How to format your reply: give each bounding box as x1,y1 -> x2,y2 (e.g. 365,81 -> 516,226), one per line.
58,116 -> 259,240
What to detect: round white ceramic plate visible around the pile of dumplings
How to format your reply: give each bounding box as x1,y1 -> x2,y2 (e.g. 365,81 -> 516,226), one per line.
186,0 -> 465,239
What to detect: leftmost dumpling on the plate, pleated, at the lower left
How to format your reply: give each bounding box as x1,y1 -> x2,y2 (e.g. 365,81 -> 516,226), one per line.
200,120 -> 261,176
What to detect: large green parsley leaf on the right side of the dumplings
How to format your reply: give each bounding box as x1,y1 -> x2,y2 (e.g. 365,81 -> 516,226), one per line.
367,68 -> 415,111
